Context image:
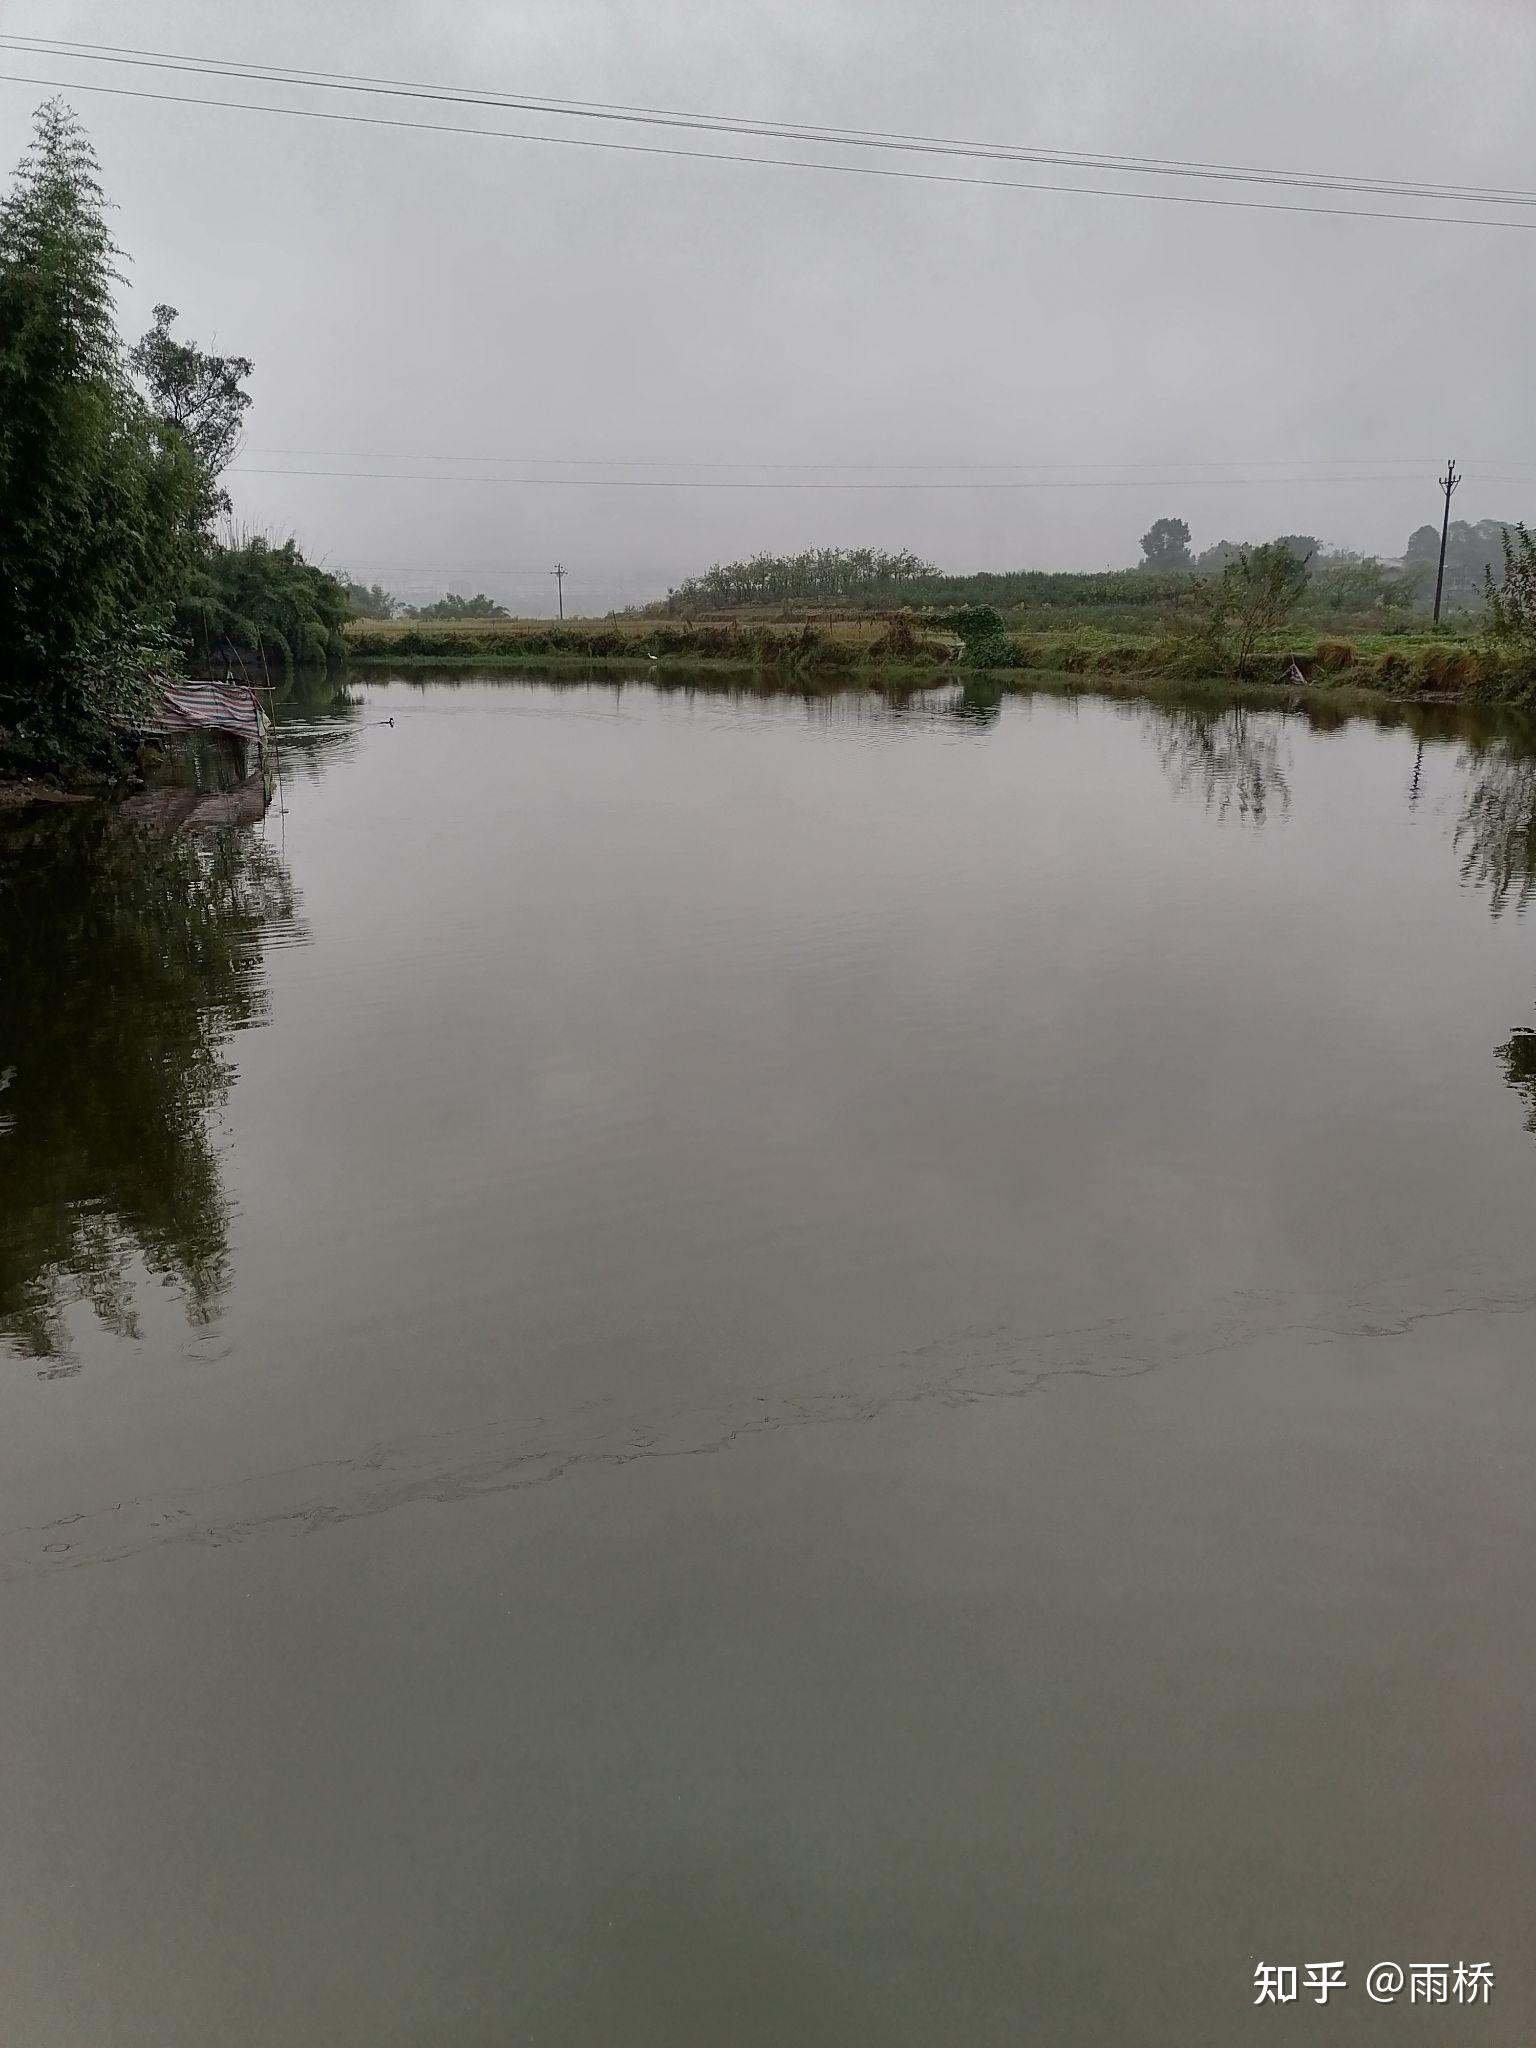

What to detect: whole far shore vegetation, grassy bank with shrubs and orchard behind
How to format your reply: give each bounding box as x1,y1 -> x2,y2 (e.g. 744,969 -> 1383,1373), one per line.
346,518 -> 1536,702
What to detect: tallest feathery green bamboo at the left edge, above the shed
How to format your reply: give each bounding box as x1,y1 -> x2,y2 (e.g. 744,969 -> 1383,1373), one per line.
0,100 -> 201,760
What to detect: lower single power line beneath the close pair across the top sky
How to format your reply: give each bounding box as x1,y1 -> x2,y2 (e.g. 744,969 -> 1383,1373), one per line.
0,72 -> 1536,231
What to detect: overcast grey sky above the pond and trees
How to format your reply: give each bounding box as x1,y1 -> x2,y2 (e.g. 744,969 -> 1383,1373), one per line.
0,0 -> 1536,610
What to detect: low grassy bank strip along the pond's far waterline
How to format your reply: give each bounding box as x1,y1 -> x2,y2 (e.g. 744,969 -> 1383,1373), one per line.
346,614 -> 1536,702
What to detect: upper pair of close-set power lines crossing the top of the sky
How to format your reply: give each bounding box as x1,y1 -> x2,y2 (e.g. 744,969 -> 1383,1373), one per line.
0,35 -> 1536,207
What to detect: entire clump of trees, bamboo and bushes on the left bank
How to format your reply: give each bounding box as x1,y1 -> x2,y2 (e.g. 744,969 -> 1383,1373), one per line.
0,100 -> 346,774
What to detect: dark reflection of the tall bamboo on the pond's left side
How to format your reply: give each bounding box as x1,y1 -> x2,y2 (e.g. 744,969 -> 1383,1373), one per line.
0,807 -> 299,1370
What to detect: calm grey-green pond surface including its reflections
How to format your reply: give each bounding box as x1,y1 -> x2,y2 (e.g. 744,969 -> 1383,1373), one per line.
0,682 -> 1536,2048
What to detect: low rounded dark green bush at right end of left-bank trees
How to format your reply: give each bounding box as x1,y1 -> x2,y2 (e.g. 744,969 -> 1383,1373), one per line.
176,535 -> 346,668
